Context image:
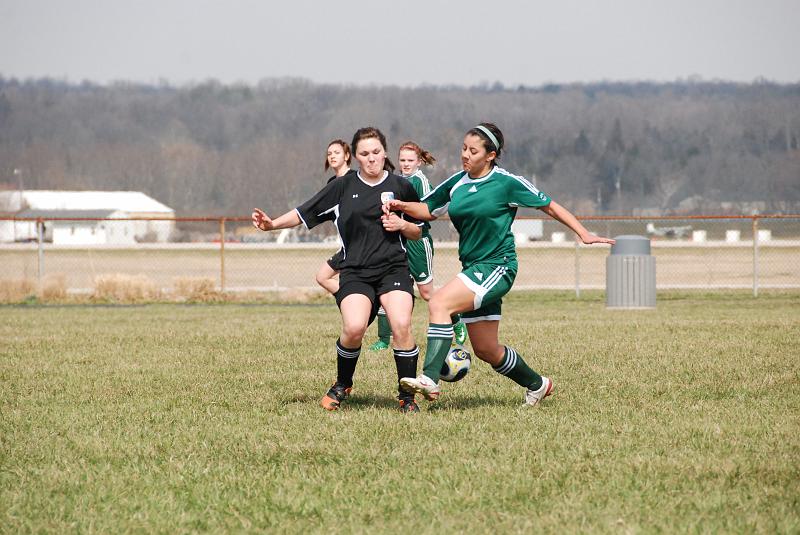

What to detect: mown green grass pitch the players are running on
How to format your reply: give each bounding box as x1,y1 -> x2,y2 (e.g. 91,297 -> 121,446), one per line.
0,292 -> 800,533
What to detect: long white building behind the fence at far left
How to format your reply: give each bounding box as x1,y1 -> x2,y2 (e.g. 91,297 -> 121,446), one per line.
0,190 -> 175,245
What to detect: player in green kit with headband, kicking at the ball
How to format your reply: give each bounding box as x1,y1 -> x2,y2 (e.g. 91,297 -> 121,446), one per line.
384,123 -> 614,406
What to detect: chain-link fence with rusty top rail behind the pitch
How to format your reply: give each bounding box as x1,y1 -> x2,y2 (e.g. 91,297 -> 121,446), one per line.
0,215 -> 800,296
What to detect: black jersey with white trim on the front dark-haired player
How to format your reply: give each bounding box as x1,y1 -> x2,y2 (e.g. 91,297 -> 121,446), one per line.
296,173 -> 421,271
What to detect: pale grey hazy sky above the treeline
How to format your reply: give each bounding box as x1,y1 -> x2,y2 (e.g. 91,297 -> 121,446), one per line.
0,0 -> 800,87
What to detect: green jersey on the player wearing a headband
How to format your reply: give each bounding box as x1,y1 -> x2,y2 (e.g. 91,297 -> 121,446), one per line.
422,166 -> 550,268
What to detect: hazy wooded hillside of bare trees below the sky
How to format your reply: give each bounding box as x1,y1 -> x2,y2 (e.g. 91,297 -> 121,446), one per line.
0,77 -> 800,216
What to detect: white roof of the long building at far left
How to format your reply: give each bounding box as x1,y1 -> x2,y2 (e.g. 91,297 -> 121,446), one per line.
0,190 -> 175,215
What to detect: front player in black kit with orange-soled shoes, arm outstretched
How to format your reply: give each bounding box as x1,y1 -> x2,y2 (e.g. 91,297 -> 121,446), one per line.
252,127 -> 422,412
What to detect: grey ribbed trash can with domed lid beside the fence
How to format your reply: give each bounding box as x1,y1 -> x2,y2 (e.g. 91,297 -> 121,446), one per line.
606,236 -> 656,308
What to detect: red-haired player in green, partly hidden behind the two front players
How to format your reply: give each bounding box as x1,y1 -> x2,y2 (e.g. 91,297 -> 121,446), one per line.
369,141 -> 467,351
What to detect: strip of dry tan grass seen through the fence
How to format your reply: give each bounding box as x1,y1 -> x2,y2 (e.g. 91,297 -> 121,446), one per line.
0,243 -> 800,294
